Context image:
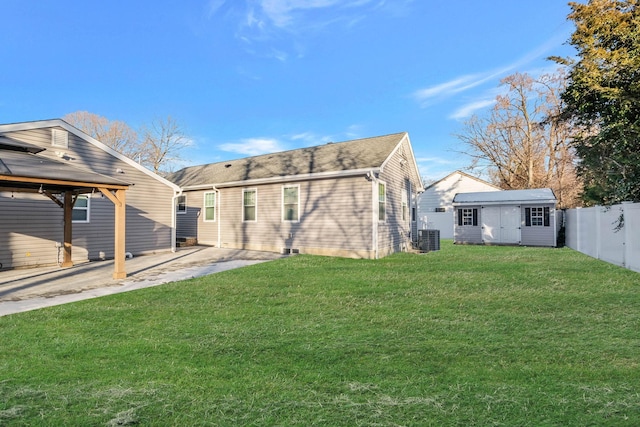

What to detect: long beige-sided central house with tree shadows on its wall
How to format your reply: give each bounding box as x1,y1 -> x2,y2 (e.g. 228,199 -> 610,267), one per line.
168,132 -> 422,258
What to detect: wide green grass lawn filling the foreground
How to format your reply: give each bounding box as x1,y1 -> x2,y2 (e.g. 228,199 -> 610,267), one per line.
0,242 -> 640,426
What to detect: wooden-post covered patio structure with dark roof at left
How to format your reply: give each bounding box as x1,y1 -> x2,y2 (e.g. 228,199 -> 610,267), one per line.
0,135 -> 131,279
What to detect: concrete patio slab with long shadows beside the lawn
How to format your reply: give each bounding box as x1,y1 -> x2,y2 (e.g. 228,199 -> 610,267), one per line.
0,246 -> 283,316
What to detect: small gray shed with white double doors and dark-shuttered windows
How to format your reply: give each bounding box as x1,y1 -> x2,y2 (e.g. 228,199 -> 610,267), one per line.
453,188 -> 561,247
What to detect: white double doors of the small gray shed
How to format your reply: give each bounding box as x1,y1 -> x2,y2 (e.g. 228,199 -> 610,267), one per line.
482,206 -> 521,244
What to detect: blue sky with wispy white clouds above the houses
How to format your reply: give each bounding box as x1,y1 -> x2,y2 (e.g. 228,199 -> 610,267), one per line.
0,0 -> 573,179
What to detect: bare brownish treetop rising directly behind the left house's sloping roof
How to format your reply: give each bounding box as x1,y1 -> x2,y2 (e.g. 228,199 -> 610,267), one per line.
63,111 -> 140,159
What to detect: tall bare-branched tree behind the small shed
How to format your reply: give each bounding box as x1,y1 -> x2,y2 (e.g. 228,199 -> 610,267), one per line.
457,72 -> 581,207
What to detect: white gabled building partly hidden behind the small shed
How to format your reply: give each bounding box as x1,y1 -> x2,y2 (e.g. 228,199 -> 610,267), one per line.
418,171 -> 501,239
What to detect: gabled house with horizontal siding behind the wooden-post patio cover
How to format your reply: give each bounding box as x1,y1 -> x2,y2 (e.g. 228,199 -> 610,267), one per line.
0,119 -> 179,268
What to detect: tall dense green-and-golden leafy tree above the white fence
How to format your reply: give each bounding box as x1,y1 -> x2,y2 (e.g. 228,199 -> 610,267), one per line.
552,0 -> 640,205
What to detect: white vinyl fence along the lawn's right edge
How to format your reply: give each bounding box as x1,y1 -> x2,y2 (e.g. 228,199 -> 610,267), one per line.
565,203 -> 640,272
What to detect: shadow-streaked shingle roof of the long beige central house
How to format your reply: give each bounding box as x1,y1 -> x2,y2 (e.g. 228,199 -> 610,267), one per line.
167,132 -> 407,187
